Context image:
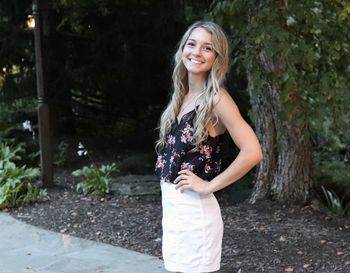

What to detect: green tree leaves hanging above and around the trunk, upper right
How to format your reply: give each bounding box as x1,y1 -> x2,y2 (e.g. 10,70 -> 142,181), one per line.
208,0 -> 350,142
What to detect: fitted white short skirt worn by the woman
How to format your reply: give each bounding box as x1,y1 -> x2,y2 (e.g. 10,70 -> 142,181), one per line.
160,182 -> 223,273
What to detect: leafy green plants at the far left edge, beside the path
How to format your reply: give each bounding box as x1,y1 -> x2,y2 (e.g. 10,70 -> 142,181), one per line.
0,140 -> 47,209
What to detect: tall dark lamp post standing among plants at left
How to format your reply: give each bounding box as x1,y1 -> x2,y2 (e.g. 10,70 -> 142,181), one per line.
33,0 -> 54,187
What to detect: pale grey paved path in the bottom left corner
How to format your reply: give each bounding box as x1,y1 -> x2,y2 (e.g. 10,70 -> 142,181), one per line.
0,212 -> 167,273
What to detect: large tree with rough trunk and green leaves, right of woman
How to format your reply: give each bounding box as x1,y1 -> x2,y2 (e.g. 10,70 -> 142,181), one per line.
210,0 -> 350,203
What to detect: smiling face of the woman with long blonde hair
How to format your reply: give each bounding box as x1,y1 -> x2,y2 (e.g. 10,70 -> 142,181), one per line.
182,27 -> 216,75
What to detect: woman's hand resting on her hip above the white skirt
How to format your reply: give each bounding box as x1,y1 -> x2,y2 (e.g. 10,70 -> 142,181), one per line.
174,170 -> 211,194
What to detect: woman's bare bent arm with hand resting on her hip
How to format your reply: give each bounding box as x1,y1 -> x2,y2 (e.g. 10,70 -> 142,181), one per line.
174,90 -> 263,194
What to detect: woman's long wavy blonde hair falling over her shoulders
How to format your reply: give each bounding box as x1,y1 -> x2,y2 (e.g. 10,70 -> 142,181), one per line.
155,21 -> 229,154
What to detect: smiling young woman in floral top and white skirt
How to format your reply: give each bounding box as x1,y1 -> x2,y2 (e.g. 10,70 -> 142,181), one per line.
155,21 -> 262,273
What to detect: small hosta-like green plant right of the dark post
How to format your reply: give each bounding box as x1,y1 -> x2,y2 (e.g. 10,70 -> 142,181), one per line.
72,163 -> 118,195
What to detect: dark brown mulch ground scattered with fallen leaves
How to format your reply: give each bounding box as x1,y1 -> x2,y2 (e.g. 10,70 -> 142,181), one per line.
5,170 -> 350,273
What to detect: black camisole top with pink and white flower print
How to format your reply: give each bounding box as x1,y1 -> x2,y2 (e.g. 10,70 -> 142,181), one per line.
155,110 -> 222,183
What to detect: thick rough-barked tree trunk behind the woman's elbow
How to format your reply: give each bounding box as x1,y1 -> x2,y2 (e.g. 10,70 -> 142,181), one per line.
247,54 -> 312,203
